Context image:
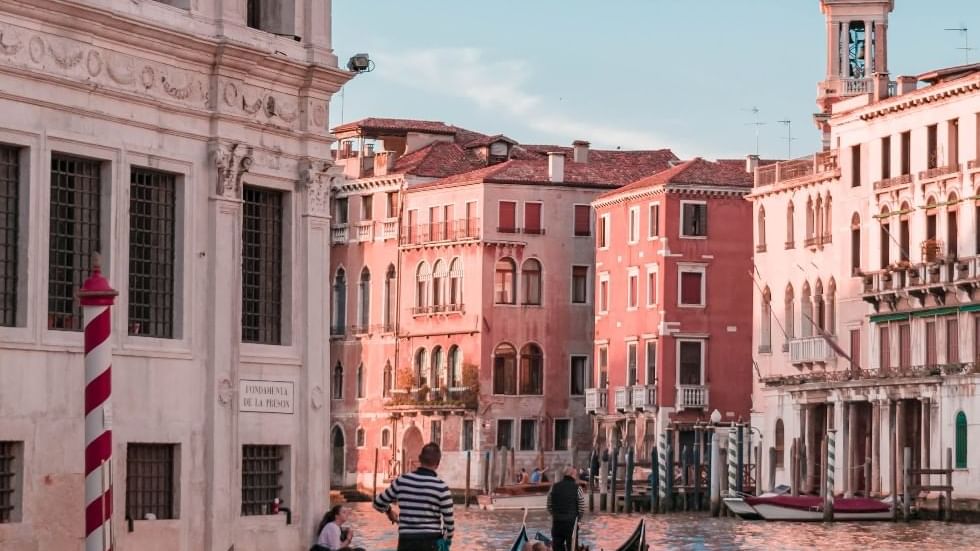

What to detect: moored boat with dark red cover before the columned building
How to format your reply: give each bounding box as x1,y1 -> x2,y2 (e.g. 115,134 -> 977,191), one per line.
748,496 -> 892,522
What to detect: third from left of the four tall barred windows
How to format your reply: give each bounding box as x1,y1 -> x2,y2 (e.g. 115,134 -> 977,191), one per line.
129,168 -> 177,339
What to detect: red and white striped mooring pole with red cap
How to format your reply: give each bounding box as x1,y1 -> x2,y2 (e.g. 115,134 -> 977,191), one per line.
78,253 -> 118,551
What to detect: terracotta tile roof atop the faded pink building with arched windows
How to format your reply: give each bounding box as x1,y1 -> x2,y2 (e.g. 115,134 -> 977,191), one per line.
412,147 -> 677,193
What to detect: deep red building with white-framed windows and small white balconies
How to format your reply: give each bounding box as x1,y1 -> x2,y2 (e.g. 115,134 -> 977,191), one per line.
586,158 -> 754,459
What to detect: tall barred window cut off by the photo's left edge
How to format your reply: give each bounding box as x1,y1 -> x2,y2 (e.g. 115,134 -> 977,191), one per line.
0,145 -> 20,327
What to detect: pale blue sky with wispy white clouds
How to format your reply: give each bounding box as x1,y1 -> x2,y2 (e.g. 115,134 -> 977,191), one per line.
330,0 -> 980,159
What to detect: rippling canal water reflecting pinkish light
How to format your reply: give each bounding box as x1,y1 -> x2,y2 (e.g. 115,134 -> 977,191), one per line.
342,503 -> 980,551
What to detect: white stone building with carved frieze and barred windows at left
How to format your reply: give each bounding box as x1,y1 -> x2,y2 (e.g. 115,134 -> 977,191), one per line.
0,0 -> 351,551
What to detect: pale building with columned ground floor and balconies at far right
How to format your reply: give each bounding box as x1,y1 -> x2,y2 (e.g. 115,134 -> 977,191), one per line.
752,2 -> 980,497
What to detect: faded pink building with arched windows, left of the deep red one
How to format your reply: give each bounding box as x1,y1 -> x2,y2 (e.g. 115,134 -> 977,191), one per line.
332,119 -> 675,487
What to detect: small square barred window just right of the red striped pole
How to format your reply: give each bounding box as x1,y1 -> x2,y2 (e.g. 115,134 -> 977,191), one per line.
126,444 -> 176,520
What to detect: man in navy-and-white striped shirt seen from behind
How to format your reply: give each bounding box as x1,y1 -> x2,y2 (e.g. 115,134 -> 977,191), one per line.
374,443 -> 454,551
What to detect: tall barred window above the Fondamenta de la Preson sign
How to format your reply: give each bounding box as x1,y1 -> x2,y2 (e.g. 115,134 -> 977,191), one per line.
242,186 -> 283,344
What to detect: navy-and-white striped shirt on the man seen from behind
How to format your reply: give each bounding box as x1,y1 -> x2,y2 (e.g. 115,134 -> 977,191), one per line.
374,467 -> 454,539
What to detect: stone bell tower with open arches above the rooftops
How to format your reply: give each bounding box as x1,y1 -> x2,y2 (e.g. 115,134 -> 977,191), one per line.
813,0 -> 895,147
